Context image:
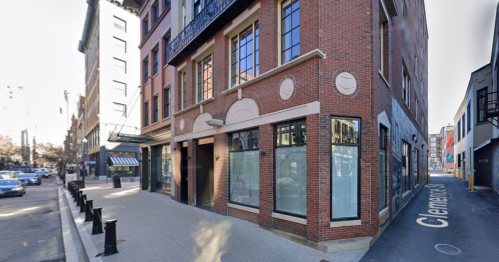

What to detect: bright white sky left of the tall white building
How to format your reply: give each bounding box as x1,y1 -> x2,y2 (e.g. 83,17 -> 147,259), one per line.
0,0 -> 87,144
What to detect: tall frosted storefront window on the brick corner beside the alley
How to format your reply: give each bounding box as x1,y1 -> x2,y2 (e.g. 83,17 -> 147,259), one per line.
331,118 -> 360,220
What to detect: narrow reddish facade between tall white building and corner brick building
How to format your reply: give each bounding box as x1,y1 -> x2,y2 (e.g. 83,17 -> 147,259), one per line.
139,0 -> 174,194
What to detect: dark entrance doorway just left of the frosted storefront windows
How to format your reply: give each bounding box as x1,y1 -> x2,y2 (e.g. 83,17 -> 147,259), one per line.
196,144 -> 214,205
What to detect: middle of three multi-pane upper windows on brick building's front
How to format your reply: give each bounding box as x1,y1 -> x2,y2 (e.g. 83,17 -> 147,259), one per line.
230,21 -> 260,86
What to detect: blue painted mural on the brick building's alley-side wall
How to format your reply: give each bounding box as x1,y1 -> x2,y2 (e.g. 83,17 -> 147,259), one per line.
391,99 -> 428,213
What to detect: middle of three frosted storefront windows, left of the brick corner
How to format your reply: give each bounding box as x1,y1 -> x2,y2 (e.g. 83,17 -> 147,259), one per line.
275,120 -> 307,217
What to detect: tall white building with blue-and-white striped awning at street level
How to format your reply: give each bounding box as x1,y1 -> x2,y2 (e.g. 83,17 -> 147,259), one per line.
78,0 -> 140,179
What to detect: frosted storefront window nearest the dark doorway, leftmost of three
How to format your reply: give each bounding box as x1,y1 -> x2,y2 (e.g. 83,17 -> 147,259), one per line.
229,129 -> 260,207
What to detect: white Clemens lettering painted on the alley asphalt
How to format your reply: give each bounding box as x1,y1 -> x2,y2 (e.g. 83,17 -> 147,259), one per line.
416,184 -> 449,228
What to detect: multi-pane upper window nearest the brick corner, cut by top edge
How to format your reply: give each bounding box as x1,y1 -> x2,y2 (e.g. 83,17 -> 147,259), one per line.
281,0 -> 300,64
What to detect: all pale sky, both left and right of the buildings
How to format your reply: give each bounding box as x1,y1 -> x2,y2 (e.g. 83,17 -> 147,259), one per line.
0,0 -> 498,144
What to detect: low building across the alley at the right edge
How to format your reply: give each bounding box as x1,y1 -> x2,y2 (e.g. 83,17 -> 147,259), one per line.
454,64 -> 493,187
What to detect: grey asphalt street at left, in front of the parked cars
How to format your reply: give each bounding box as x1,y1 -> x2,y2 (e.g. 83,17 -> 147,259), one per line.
0,178 -> 65,262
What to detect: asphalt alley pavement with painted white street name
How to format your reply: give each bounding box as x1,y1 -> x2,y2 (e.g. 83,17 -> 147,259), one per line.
361,172 -> 499,262
